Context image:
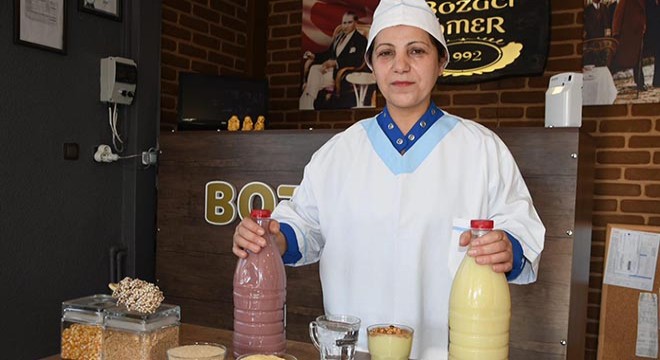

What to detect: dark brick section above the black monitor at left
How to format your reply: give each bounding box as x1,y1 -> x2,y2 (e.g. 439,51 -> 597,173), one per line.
161,0 -> 248,128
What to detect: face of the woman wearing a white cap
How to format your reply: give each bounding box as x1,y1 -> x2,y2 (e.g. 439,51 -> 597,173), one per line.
371,25 -> 444,116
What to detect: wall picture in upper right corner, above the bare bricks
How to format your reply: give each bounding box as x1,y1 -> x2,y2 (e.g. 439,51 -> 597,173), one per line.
582,0 -> 660,105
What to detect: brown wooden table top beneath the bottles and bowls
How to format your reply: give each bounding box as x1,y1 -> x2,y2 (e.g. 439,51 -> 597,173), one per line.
43,324 -> 371,360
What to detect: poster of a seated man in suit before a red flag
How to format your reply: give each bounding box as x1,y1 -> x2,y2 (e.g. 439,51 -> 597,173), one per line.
299,0 -> 379,110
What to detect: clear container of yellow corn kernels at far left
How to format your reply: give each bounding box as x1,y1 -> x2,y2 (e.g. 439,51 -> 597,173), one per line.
60,294 -> 116,360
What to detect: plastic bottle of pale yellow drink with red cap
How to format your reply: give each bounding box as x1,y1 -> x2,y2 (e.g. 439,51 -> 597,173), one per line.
449,220 -> 511,360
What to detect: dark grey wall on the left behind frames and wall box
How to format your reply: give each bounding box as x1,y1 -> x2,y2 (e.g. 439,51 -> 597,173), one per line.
0,0 -> 161,359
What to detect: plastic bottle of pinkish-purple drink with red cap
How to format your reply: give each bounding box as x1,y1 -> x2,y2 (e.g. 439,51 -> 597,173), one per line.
233,210 -> 286,357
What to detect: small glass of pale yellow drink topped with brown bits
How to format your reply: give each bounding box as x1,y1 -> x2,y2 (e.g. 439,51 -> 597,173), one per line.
367,324 -> 414,360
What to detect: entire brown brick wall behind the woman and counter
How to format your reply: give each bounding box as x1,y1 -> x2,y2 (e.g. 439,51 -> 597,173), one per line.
162,0 -> 660,359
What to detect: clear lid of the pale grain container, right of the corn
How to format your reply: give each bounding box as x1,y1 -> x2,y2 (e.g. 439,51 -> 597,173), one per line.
104,304 -> 181,332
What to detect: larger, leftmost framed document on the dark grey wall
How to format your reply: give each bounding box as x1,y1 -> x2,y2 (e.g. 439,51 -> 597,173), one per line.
14,0 -> 66,54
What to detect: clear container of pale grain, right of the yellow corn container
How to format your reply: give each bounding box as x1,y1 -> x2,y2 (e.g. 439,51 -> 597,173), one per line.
102,304 -> 181,360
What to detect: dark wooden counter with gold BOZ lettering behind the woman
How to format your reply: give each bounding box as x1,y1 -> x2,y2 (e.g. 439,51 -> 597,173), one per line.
156,128 -> 595,360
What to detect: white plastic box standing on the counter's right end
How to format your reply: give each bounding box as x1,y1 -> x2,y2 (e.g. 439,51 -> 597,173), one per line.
545,73 -> 582,127
